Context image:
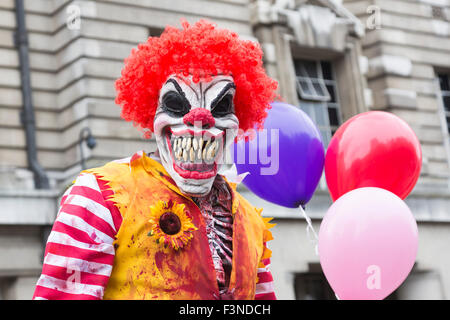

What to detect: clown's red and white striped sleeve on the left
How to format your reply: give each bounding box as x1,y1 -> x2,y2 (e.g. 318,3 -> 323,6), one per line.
33,173 -> 122,300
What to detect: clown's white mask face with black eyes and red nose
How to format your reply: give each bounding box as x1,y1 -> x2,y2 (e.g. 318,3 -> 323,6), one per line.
154,75 -> 239,196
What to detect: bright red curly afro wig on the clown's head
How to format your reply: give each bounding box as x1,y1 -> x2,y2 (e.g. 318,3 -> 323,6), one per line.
115,20 -> 277,136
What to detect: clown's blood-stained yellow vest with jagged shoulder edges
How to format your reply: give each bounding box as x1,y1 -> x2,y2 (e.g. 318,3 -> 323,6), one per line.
86,153 -> 272,299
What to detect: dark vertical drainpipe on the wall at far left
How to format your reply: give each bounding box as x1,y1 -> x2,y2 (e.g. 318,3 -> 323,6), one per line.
15,0 -> 50,189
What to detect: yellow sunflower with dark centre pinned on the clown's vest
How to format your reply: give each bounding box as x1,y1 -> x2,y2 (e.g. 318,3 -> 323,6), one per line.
148,200 -> 198,250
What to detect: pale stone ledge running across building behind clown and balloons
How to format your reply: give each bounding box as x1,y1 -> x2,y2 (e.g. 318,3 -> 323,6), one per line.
0,180 -> 450,226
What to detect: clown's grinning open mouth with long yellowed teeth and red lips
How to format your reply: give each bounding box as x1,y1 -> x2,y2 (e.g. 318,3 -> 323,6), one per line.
166,130 -> 223,179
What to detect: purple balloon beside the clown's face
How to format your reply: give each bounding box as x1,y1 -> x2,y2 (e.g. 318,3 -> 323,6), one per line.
232,102 -> 325,208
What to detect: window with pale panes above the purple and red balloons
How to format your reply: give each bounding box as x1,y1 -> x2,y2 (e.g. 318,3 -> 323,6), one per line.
294,59 -> 342,147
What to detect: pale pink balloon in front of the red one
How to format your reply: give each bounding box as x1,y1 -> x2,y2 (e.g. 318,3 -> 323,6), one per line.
319,187 -> 418,300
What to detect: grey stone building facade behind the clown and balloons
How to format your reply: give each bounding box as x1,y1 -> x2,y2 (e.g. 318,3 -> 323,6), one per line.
0,0 -> 450,299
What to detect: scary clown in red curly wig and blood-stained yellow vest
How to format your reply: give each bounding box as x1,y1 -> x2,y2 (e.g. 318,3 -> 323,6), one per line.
34,20 -> 277,299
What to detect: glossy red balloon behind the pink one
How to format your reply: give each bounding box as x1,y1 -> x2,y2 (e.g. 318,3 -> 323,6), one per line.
325,111 -> 422,201
